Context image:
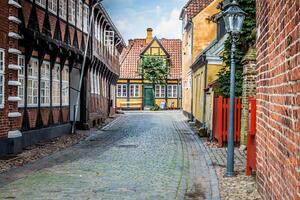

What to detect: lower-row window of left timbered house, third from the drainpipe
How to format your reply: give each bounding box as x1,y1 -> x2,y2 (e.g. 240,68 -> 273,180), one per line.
40,62 -> 50,106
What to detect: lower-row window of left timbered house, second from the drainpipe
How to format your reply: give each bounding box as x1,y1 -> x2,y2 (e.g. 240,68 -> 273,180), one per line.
52,64 -> 60,106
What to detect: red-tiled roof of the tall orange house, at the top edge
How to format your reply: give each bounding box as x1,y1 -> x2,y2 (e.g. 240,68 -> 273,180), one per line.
180,0 -> 214,19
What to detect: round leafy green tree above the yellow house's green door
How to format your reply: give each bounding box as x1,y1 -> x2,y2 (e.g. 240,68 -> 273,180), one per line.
138,56 -> 169,85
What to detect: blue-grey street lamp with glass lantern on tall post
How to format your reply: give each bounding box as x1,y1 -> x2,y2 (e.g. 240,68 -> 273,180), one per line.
223,0 -> 246,177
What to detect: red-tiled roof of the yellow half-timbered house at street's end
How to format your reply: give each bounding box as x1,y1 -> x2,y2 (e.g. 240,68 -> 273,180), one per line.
120,39 -> 182,79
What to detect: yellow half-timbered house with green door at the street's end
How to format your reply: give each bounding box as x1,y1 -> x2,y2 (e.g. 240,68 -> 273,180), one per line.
116,28 -> 181,109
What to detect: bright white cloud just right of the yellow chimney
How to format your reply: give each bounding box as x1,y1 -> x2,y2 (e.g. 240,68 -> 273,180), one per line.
155,8 -> 181,38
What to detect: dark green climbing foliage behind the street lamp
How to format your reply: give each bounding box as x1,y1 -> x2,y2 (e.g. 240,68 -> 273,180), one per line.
216,0 -> 256,97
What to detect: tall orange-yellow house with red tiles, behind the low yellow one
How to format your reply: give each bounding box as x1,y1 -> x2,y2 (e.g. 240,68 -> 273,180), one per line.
180,0 -> 220,119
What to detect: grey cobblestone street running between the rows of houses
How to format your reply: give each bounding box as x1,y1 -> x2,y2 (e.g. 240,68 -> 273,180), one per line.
0,112 -> 219,200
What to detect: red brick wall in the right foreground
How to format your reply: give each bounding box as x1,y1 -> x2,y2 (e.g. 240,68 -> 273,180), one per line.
256,0 -> 300,200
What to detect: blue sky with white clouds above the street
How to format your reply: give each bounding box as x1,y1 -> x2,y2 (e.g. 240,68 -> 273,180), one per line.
102,0 -> 187,42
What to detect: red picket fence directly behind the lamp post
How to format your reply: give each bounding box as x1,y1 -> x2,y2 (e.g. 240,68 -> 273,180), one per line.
212,97 -> 242,147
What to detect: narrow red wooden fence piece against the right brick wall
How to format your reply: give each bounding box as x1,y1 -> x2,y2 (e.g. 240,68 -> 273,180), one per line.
246,97 -> 256,176
